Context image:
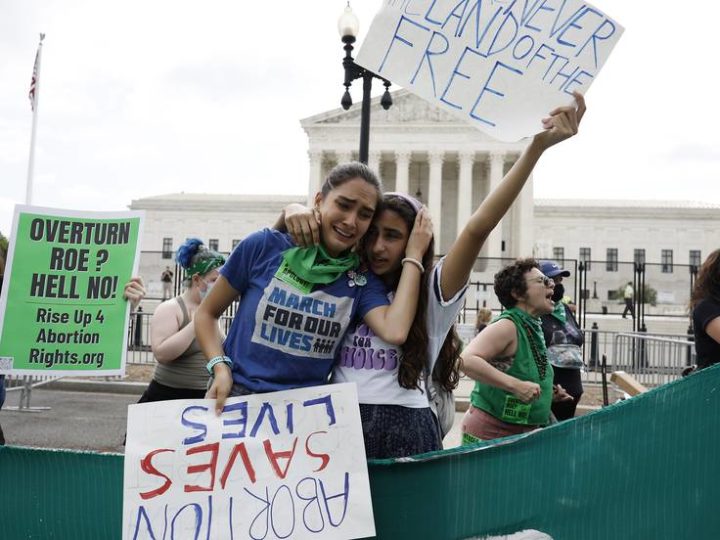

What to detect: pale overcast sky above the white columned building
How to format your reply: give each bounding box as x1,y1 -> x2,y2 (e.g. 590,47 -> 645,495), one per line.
0,0 -> 720,234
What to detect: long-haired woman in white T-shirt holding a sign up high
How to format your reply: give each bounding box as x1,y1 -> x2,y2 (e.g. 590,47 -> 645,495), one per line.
286,94 -> 585,458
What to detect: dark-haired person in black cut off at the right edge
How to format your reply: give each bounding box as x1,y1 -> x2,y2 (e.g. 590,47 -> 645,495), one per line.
690,249 -> 720,369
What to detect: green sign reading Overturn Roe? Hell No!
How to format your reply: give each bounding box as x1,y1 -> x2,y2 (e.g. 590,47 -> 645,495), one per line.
0,206 -> 143,376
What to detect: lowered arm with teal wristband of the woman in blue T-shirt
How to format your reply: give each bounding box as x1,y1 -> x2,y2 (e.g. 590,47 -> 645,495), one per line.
195,275 -> 238,415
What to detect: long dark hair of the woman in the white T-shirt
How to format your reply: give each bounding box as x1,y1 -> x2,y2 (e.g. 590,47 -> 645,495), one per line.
361,195 -> 461,391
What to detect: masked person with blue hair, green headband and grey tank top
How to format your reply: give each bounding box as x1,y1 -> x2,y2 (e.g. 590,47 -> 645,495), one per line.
138,238 -> 225,403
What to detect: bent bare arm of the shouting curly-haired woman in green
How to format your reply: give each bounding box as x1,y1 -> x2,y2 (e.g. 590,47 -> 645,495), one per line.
460,319 -> 540,403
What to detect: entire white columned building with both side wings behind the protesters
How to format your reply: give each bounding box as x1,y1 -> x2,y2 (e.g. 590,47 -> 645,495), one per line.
130,90 -> 720,320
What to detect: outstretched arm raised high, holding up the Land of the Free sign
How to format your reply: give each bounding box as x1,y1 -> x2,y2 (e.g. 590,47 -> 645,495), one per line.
440,92 -> 585,299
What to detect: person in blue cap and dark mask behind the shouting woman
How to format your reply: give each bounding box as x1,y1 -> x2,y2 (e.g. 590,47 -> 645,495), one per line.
540,261 -> 584,420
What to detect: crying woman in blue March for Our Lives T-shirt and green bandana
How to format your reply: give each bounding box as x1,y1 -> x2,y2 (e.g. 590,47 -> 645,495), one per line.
195,163 -> 432,413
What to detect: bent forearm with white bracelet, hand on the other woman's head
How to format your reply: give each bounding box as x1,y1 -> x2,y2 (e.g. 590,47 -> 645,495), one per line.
364,208 -> 432,345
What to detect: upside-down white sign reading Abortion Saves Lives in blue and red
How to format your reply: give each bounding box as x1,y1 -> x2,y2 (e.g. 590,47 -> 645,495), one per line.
123,384 -> 375,540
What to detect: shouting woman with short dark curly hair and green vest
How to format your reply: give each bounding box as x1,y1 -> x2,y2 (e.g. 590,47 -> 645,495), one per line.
461,259 -> 571,444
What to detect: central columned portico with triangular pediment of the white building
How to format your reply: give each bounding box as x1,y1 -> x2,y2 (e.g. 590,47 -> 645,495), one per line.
300,90 -> 533,257
